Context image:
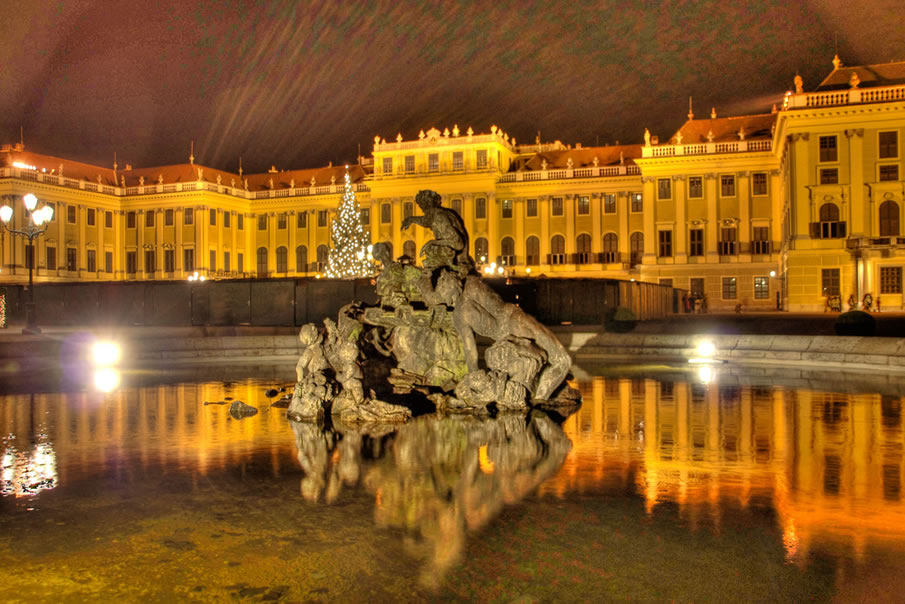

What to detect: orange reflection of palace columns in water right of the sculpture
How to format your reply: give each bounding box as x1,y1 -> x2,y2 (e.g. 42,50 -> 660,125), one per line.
541,374 -> 905,564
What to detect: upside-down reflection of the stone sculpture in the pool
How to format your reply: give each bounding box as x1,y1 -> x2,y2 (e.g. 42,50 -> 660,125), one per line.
291,412 -> 571,587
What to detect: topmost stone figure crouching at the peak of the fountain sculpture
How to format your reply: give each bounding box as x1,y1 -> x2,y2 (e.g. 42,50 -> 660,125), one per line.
402,191 -> 474,274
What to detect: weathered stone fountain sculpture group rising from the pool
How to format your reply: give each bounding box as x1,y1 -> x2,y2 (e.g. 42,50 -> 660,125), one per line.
288,191 -> 580,422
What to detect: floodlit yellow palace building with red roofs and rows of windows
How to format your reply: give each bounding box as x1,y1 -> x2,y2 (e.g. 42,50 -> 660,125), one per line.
0,58 -> 905,311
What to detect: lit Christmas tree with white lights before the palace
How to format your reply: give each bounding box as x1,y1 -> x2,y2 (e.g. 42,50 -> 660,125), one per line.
326,166 -> 374,279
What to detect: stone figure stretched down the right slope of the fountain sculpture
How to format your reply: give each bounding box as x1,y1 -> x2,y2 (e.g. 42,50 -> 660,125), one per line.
421,271 -> 572,399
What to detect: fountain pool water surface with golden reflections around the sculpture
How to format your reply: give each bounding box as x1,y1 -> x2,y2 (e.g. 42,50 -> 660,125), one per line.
0,366 -> 905,602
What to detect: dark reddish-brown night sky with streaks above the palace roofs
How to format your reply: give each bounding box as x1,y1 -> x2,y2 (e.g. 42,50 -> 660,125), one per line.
0,0 -> 905,171
